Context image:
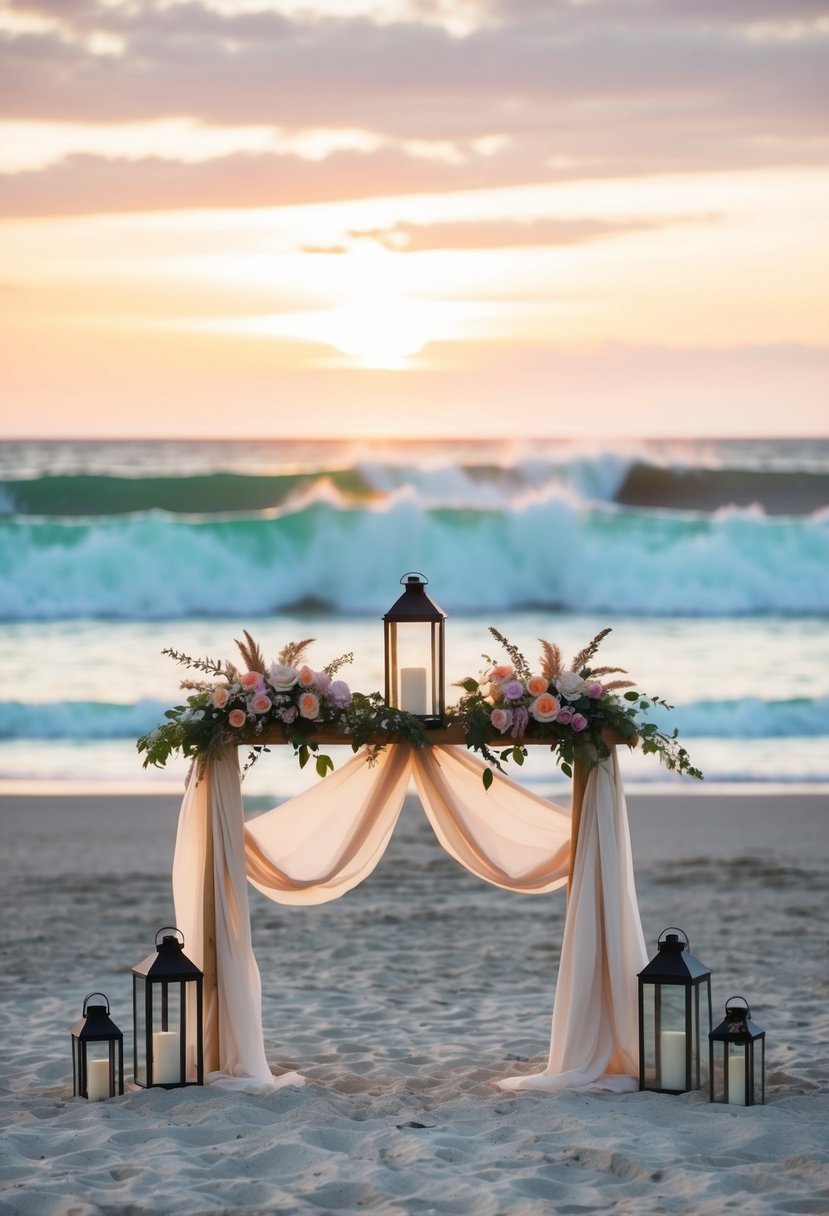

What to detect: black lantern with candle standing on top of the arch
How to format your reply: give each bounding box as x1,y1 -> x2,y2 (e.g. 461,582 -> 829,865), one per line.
383,573 -> 446,727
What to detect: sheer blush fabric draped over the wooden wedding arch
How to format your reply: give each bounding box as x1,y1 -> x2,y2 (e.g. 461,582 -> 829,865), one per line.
173,744 -> 647,1092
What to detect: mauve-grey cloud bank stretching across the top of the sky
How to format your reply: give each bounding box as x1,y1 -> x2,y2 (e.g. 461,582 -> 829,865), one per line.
0,0 -> 829,214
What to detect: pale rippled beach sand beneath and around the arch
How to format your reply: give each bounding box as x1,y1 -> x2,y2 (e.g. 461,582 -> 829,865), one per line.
0,792 -> 829,1216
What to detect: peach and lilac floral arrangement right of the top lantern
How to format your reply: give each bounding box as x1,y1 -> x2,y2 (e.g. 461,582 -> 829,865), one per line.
453,629 -> 703,788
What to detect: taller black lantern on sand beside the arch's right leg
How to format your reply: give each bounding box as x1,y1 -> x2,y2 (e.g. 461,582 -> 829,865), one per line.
639,929 -> 711,1093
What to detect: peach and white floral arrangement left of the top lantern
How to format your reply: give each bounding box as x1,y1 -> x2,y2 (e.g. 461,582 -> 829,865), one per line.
137,630 -> 353,777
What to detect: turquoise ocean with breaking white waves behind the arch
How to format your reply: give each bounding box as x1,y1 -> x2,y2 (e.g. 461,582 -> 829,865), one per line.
0,439 -> 829,801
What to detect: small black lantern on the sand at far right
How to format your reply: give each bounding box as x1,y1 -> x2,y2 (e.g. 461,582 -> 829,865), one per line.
709,996 -> 766,1107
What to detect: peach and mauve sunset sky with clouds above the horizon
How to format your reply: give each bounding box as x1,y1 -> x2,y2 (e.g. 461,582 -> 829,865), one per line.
0,0 -> 829,438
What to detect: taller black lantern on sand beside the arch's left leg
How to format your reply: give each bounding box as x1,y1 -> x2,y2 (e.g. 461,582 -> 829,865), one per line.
132,925 -> 204,1090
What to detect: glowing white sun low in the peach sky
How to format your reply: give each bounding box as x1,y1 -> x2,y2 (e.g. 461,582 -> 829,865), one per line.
326,294 -> 435,368
